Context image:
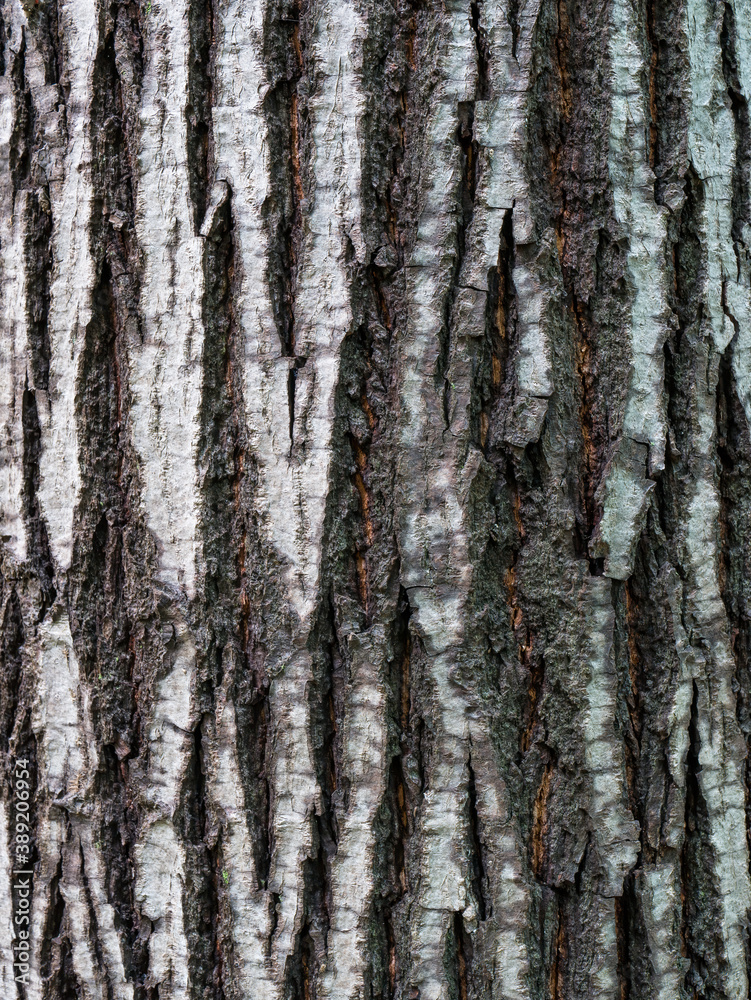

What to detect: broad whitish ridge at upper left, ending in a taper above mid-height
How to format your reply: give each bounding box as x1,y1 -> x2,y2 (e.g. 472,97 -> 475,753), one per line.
129,3 -> 203,598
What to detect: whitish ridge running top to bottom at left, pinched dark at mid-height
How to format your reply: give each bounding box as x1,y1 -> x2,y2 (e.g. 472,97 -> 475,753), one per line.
122,3 -> 204,998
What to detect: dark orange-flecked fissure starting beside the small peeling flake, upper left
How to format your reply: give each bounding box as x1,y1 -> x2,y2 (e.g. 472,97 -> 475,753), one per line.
197,76 -> 280,900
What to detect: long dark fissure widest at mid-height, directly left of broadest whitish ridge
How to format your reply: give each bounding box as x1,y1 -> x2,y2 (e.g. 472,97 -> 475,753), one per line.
69,240 -> 148,1000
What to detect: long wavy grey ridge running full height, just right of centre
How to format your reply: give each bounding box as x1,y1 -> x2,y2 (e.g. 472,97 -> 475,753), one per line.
398,3 -> 477,1000
